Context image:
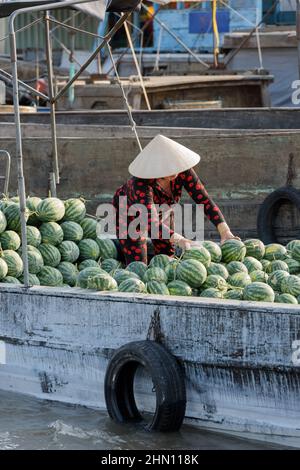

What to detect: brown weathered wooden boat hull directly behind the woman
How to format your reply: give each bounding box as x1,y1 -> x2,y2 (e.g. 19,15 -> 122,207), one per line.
0,125 -> 300,238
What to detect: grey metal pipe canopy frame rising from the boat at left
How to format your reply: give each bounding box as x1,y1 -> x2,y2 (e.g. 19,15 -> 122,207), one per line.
0,0 -> 134,288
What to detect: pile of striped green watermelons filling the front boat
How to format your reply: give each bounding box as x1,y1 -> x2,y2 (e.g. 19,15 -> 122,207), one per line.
0,197 -> 300,305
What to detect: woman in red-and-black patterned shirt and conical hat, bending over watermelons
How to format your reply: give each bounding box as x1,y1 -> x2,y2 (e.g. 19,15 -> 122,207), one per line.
113,135 -> 238,264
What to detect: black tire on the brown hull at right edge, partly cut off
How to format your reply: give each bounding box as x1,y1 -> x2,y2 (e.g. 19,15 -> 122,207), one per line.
257,186 -> 300,244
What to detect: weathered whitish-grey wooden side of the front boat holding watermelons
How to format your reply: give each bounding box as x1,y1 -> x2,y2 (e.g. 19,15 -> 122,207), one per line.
0,284 -> 300,446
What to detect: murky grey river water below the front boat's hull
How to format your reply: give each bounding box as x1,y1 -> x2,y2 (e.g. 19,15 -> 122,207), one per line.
0,391 -> 286,450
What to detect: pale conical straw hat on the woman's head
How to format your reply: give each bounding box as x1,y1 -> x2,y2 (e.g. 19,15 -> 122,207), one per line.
128,134 -> 200,179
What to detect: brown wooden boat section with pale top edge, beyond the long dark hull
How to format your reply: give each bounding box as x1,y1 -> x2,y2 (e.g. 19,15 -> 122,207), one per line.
57,74 -> 273,110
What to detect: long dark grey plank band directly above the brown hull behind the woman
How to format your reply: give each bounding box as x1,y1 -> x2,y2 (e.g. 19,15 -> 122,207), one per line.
1,108 -> 300,132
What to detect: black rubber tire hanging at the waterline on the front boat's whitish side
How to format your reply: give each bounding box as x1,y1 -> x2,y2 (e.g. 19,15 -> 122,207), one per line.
104,340 -> 186,432
